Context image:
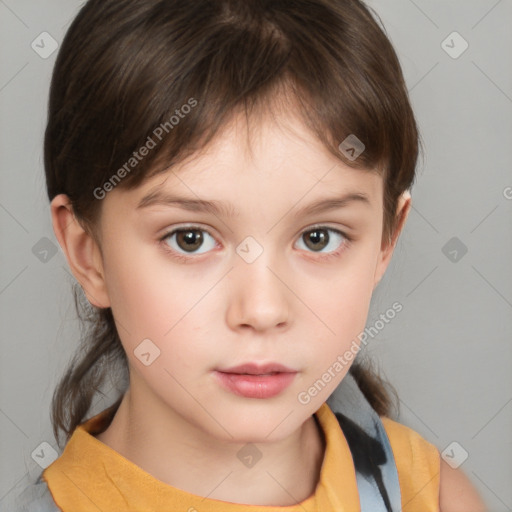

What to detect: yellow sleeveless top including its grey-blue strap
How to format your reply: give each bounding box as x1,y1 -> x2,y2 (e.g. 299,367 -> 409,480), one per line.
9,374 -> 440,512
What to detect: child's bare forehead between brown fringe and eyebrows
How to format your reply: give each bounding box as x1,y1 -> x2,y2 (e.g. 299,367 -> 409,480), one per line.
107,111 -> 382,214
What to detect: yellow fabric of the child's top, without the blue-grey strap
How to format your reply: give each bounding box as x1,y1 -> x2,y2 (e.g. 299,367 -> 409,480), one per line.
43,403 -> 440,512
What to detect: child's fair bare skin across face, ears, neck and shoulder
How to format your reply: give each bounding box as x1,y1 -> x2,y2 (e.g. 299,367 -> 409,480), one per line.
51,107 -> 483,512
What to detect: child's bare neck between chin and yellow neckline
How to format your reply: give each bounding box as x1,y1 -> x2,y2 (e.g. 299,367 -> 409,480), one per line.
96,389 -> 325,506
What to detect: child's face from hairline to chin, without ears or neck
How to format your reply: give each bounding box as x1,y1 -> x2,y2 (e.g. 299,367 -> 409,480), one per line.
90,110 -> 400,442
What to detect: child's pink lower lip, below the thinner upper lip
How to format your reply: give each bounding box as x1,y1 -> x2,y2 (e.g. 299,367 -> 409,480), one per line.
215,371 -> 297,398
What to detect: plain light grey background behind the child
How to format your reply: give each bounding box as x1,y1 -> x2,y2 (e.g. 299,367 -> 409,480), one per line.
0,0 -> 512,511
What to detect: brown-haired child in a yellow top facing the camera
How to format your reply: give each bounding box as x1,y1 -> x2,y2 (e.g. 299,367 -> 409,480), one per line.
12,0 -> 484,512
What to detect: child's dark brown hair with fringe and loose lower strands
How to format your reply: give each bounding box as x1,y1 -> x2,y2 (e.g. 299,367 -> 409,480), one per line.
44,0 -> 420,448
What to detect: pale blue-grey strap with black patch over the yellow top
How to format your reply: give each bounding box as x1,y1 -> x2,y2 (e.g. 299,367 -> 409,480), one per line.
327,372 -> 402,512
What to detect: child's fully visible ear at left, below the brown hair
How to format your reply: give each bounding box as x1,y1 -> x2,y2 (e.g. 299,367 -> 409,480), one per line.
51,194 -> 110,308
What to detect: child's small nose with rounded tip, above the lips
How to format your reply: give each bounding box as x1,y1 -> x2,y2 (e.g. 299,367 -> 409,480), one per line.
226,252 -> 292,332
